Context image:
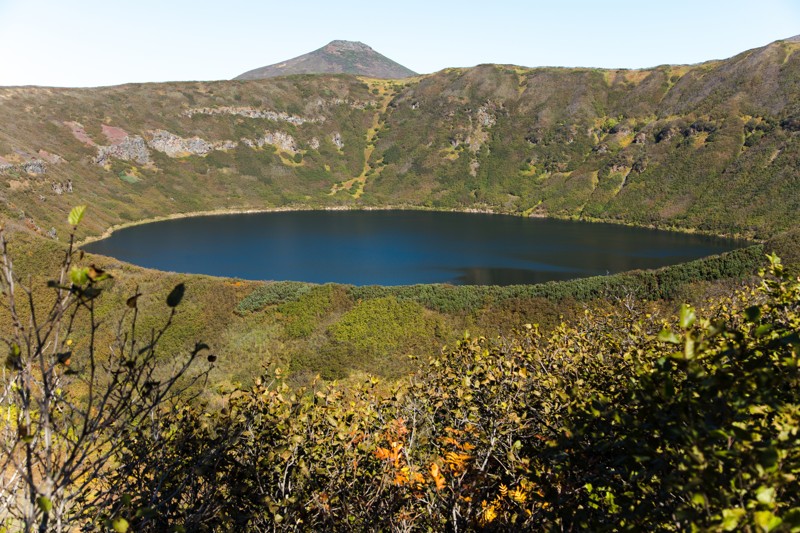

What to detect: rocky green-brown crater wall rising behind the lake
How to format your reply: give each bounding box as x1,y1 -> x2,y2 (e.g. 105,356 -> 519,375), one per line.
0,41 -> 800,244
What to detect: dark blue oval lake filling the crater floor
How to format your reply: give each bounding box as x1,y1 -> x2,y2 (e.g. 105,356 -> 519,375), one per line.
84,211 -> 746,285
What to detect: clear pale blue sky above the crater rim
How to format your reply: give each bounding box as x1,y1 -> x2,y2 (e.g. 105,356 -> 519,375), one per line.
0,0 -> 800,87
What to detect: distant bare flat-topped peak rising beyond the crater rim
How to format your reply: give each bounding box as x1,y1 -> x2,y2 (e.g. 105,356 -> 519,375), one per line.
234,40 -> 417,80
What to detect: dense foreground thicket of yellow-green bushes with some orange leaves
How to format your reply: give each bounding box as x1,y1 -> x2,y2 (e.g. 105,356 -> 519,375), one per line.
92,257 -> 800,531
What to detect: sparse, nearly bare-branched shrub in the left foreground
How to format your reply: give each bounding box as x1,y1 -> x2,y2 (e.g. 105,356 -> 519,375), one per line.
0,207 -> 213,532
